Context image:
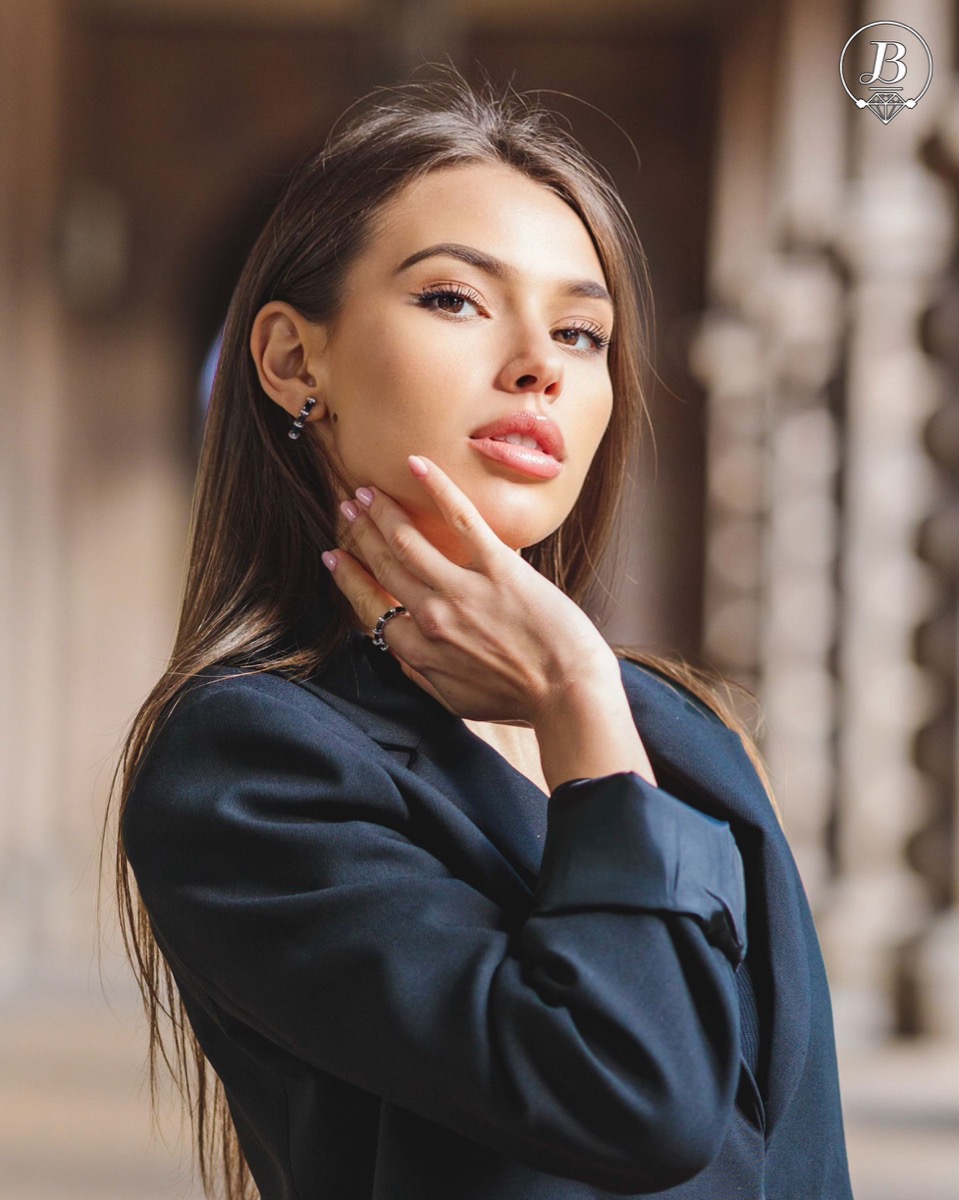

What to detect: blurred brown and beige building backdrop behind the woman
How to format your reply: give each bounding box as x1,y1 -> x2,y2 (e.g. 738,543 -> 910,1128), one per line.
0,0 -> 959,1200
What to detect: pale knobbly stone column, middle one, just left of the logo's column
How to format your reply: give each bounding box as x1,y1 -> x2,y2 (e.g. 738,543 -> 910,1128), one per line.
750,0 -> 845,912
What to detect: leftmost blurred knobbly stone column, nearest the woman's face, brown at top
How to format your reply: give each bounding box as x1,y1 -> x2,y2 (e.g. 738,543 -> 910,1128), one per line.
690,5 -> 777,700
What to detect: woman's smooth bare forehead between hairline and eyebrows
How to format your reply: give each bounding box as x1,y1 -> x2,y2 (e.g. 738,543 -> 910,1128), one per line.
367,163 -> 605,282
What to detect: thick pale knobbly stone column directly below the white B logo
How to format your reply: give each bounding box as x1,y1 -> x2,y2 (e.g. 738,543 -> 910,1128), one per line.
822,0 -> 952,1044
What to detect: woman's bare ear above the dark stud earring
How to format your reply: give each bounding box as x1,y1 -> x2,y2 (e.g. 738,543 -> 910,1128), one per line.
250,300 -> 325,420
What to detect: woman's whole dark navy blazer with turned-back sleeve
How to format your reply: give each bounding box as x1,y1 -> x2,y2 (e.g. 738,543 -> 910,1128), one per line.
122,634 -> 851,1200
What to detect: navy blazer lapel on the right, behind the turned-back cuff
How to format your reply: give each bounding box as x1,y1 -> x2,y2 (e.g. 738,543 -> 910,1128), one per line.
621,664 -> 810,1135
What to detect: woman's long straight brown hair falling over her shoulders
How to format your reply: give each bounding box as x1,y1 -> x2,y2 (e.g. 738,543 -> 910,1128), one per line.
108,76 -> 777,1200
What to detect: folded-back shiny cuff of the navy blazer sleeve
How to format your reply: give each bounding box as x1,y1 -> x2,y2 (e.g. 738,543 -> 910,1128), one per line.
537,772 -> 747,966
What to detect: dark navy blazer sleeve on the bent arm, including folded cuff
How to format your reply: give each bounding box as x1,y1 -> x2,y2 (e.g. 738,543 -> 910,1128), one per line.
122,676 -> 745,1192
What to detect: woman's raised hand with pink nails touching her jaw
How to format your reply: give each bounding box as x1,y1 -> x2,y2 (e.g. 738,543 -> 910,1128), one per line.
324,458 -> 619,725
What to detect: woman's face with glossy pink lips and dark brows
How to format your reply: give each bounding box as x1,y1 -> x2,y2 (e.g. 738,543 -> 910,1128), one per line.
318,164 -> 612,557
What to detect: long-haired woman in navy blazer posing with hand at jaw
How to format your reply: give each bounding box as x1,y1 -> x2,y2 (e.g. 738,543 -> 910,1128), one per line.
118,84 -> 850,1200
